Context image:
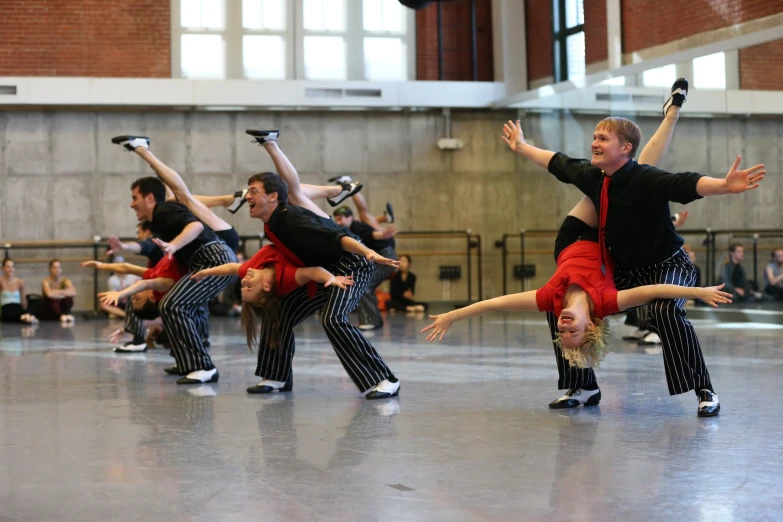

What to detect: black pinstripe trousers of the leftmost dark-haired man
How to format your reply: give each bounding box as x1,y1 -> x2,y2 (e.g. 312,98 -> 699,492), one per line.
159,242 -> 237,373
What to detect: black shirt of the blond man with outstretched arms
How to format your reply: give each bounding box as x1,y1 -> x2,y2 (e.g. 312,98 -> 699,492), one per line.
549,152 -> 702,269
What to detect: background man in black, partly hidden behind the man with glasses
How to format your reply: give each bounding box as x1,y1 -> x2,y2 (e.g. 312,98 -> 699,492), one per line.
332,204 -> 397,330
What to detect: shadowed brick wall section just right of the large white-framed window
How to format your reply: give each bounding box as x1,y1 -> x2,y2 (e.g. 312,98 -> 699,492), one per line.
416,0 -> 494,82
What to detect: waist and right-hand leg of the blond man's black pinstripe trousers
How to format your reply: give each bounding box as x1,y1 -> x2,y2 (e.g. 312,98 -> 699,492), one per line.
614,249 -> 712,395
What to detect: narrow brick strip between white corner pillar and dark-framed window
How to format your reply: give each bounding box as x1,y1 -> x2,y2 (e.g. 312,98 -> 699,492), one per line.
525,0 -> 554,81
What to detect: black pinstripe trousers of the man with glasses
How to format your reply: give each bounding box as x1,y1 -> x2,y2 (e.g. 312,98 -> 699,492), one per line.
256,254 -> 393,392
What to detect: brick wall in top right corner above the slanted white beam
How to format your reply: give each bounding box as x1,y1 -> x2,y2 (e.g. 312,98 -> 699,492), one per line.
620,0 -> 783,53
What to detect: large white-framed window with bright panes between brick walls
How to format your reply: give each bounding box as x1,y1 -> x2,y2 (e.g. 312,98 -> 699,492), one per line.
172,0 -> 415,81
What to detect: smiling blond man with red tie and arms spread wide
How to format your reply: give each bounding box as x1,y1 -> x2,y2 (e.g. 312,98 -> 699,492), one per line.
503,99 -> 766,416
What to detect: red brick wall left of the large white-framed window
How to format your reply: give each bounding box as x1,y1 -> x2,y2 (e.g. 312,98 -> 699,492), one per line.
0,0 -> 171,78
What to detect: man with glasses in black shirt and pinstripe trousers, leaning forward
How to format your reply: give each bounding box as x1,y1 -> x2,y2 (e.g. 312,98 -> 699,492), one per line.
247,129 -> 400,399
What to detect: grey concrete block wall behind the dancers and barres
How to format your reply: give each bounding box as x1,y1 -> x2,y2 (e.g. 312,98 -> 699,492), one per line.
0,107 -> 783,309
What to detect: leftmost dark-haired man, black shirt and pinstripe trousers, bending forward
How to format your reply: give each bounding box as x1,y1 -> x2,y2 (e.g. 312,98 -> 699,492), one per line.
112,136 -> 236,384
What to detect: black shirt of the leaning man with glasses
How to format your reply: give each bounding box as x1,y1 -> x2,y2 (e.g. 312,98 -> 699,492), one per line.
267,205 -> 359,266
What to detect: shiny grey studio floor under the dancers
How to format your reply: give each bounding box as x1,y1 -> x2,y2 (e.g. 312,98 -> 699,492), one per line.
0,308 -> 783,522
